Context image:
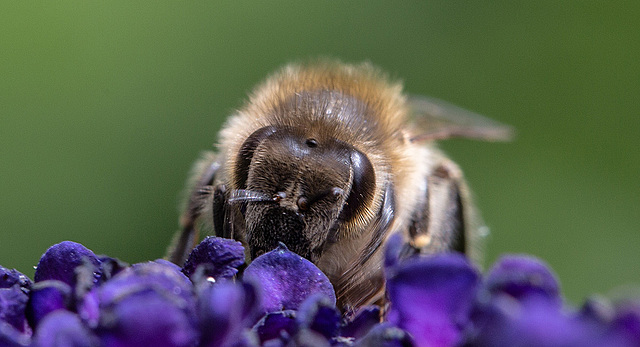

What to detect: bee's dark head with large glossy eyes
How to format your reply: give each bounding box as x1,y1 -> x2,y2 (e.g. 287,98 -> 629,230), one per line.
234,126 -> 375,261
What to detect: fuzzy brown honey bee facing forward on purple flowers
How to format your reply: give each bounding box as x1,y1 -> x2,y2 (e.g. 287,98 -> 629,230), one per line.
168,61 -> 511,310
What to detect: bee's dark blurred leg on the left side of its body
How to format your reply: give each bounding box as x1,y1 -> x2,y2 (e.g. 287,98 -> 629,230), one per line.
166,153 -> 220,265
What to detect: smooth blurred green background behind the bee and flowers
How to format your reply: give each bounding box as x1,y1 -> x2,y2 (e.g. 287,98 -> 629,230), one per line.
0,1 -> 640,303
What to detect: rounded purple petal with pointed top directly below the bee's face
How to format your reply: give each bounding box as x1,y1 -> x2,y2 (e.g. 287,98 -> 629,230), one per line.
243,244 -> 336,312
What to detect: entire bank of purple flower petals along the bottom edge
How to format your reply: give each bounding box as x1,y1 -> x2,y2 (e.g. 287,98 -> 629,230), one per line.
0,238 -> 640,347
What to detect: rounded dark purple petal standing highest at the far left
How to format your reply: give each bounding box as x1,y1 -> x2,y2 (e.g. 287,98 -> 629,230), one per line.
34,241 -> 102,288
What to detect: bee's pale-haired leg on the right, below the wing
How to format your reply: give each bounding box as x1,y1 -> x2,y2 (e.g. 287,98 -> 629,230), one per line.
409,161 -> 467,254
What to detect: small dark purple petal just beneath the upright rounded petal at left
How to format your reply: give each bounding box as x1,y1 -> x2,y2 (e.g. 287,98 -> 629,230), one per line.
26,280 -> 71,328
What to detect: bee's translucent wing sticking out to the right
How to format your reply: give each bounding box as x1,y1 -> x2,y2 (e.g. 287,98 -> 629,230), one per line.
407,95 -> 514,142
